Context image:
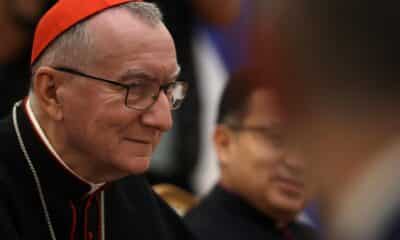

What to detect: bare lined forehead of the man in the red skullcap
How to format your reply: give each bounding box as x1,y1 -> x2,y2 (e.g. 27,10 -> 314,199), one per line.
84,11 -> 177,78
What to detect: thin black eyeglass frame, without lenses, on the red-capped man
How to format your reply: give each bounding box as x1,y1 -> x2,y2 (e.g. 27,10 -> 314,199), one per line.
51,66 -> 189,111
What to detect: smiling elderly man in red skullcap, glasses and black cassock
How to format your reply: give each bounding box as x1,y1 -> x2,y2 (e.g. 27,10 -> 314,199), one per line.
0,0 -> 190,240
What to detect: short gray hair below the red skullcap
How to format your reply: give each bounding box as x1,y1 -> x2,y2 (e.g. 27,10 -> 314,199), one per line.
31,2 -> 163,85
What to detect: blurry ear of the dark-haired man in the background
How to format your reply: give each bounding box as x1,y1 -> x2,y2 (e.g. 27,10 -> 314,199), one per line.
213,124 -> 234,167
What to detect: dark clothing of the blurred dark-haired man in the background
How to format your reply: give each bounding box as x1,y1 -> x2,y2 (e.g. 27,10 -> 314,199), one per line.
185,186 -> 316,240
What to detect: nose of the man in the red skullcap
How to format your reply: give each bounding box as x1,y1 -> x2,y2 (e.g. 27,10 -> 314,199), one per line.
142,91 -> 172,132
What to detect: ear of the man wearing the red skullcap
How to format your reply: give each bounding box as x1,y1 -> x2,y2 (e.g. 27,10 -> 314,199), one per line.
33,67 -> 63,120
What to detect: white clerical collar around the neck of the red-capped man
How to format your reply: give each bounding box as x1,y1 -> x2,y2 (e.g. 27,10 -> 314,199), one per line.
25,97 -> 104,194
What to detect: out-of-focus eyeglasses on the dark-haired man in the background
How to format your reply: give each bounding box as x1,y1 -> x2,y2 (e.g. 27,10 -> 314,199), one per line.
229,125 -> 285,148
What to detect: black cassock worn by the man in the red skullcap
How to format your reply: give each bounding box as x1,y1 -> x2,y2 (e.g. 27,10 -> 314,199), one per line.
0,98 -> 191,240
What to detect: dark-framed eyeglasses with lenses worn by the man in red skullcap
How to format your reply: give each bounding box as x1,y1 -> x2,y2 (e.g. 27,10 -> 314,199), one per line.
52,67 -> 188,110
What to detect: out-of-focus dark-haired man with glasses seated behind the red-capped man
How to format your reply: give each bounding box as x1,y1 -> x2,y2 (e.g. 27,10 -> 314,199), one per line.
185,71 -> 313,240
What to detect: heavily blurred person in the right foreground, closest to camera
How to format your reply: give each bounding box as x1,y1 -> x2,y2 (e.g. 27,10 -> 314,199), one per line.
255,0 -> 400,240
